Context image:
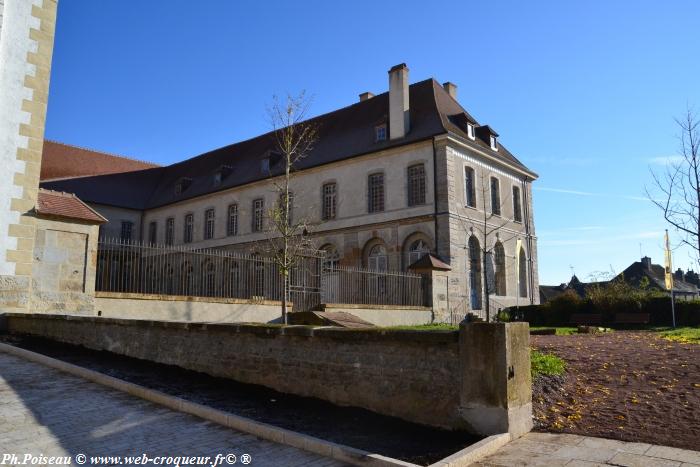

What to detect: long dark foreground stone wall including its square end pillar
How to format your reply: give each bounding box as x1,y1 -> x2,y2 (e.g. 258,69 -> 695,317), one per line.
3,313 -> 532,435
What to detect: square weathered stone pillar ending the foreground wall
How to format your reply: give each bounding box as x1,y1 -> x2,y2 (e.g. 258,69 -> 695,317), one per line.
459,323 -> 532,437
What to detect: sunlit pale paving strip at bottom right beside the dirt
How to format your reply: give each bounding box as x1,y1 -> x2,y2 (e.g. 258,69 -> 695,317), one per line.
473,433 -> 700,467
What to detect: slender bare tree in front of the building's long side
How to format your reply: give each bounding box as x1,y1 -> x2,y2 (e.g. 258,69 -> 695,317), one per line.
267,92 -> 317,324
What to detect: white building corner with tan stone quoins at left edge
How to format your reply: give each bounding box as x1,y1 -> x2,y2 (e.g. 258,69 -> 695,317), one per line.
0,0 -> 57,311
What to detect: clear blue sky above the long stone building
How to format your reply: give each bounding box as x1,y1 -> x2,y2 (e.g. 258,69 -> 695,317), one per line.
46,0 -> 700,284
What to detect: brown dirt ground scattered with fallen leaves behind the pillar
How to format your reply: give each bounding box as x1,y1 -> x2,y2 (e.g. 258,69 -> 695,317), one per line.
531,331 -> 700,450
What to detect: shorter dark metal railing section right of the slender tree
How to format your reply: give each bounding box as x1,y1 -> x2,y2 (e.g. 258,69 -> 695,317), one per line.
321,267 -> 430,306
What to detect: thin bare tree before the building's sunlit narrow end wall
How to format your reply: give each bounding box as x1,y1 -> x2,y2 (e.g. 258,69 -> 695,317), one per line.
459,172 -> 522,322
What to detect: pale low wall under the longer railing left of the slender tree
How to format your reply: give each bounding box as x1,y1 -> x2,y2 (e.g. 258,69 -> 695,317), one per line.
95,292 -> 282,323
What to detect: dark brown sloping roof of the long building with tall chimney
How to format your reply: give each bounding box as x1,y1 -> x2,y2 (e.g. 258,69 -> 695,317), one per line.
42,79 -> 537,209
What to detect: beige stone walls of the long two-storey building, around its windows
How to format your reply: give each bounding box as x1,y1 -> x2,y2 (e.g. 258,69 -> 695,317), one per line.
91,133 -> 539,321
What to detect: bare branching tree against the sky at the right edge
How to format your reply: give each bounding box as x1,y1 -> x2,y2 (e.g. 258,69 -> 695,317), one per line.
645,108 -> 700,262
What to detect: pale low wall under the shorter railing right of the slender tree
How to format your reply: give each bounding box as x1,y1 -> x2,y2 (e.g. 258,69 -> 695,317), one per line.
322,304 -> 433,327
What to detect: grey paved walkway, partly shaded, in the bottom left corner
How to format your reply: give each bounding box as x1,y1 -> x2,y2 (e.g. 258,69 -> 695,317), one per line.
0,352 -> 342,467
